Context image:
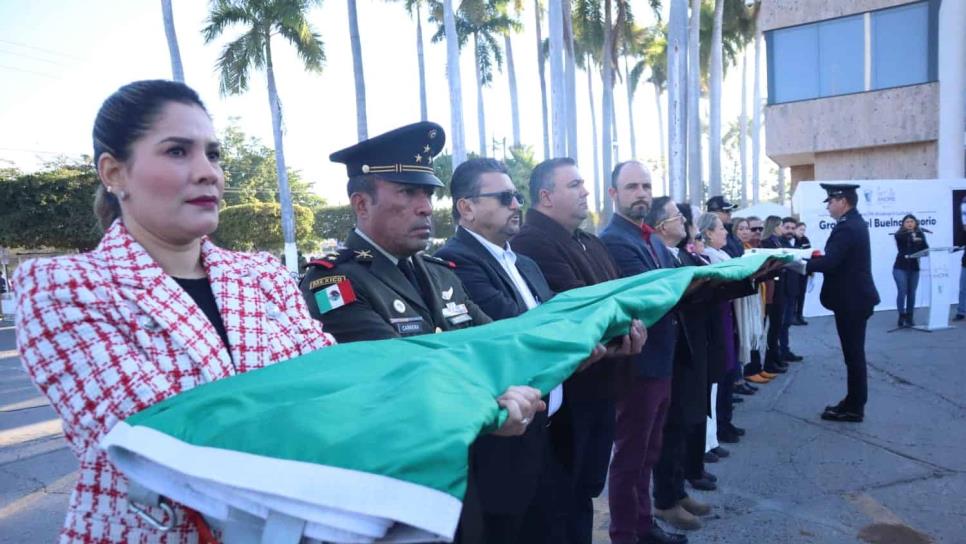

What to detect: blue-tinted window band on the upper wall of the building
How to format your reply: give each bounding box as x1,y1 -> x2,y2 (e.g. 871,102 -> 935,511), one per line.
765,0 -> 939,104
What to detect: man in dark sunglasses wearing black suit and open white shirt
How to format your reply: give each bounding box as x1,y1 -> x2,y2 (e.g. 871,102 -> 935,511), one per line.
436,159 -> 644,544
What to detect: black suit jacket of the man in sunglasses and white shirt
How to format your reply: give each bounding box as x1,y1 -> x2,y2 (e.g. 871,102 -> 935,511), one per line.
436,227 -> 553,515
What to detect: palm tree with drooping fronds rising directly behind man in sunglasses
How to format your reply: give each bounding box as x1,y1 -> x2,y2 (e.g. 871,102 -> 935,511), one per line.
433,0 -> 520,157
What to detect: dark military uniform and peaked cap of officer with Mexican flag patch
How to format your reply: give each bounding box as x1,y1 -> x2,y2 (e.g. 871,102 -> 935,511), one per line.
300,122 -> 491,342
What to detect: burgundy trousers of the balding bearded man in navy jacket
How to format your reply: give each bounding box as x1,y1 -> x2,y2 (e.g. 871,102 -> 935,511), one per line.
607,377 -> 671,544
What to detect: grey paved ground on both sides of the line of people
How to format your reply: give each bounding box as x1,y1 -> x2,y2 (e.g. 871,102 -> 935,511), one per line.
0,312 -> 966,544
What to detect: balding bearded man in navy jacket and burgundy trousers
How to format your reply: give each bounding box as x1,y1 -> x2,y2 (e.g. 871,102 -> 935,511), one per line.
600,161 -> 692,544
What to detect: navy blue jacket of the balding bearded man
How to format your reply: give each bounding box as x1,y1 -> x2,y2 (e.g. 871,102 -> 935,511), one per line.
600,215 -> 678,378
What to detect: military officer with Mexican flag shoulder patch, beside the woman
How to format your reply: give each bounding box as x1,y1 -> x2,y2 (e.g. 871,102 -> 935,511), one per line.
300,122 -> 546,543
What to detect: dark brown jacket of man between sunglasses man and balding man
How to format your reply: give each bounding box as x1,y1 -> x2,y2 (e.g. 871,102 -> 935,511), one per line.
510,208 -> 628,404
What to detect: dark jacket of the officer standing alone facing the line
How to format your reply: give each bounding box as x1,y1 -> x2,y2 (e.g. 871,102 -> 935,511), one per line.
807,209 -> 879,317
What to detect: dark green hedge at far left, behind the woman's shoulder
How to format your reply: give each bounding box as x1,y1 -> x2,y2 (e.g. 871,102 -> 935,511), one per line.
0,158 -> 101,250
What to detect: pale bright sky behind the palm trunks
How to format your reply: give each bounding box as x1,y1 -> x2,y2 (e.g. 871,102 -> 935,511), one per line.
0,0 -> 764,203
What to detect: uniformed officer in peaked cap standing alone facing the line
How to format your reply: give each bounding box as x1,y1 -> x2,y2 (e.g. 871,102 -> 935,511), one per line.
806,183 -> 879,422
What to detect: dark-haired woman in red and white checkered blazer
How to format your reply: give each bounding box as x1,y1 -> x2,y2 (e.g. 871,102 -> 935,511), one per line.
15,81 -> 334,542
